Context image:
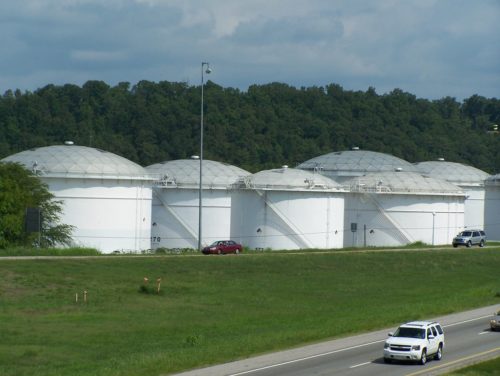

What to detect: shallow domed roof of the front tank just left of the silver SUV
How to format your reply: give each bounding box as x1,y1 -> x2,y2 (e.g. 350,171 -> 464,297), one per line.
347,171 -> 464,196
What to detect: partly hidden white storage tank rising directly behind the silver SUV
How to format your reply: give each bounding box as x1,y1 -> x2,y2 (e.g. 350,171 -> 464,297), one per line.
416,158 -> 490,230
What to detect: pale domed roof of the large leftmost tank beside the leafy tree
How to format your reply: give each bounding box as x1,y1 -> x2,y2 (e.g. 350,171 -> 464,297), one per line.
2,143 -> 152,180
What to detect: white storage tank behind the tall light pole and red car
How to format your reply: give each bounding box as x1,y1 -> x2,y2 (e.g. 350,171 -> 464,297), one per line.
146,158 -> 250,249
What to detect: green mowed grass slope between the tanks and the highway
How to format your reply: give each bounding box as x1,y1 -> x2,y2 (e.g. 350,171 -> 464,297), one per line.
0,247 -> 500,376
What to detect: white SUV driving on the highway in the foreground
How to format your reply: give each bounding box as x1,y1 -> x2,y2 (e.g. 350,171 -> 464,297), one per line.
384,321 -> 444,364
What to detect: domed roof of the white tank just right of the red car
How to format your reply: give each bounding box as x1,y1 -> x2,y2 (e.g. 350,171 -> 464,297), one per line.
241,166 -> 340,190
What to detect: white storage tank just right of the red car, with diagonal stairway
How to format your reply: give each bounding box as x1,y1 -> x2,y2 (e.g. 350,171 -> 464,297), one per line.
231,166 -> 344,250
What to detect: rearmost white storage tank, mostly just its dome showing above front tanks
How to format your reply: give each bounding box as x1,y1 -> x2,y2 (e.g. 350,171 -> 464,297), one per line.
297,147 -> 416,184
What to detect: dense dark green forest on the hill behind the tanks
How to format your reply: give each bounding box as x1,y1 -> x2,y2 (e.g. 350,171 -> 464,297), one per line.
0,81 -> 500,173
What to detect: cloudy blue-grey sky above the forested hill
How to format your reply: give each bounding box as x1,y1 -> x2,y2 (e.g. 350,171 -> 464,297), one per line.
0,0 -> 500,100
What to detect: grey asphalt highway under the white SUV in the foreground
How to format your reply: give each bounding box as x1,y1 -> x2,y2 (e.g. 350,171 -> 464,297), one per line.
173,305 -> 500,376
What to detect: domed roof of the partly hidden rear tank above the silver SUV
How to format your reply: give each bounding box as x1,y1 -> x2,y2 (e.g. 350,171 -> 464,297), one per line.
415,160 -> 490,185
